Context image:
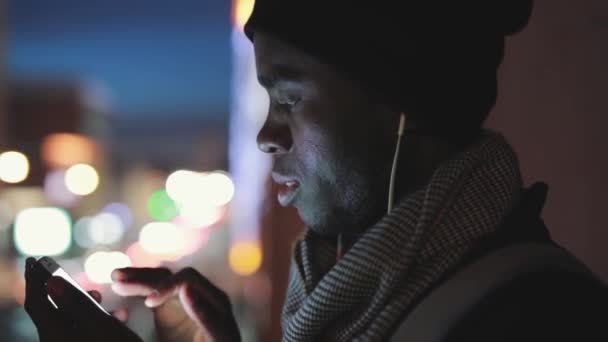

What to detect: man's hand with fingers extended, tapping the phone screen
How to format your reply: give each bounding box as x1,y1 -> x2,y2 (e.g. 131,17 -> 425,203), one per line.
112,268 -> 241,342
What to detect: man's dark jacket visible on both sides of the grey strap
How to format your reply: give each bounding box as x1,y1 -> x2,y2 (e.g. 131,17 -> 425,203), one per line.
422,183 -> 608,342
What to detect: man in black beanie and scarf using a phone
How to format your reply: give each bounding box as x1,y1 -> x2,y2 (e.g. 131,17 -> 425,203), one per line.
26,0 -> 606,341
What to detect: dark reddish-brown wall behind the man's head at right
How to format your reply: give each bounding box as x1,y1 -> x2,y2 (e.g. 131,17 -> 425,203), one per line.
488,0 -> 608,280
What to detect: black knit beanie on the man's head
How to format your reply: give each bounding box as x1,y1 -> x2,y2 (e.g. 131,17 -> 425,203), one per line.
245,0 -> 532,139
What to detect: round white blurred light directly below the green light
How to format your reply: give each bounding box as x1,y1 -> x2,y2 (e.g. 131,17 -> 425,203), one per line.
139,222 -> 188,260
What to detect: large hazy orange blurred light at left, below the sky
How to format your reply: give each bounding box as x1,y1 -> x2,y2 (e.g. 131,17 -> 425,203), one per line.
41,133 -> 98,169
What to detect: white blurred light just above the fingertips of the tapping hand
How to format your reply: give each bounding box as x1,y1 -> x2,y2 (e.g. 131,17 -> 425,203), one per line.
84,252 -> 131,284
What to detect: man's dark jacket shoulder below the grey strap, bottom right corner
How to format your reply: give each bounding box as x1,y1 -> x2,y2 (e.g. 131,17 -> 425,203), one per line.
447,270 -> 608,341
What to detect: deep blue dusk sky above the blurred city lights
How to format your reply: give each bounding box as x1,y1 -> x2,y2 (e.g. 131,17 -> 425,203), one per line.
7,0 -> 231,117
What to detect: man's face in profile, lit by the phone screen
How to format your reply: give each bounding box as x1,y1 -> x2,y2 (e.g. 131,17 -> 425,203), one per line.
254,32 -> 398,236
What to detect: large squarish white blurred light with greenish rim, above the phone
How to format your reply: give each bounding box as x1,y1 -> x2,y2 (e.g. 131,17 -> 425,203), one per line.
14,207 -> 72,256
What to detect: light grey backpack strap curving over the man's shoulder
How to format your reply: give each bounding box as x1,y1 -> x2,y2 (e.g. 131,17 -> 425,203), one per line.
390,242 -> 592,342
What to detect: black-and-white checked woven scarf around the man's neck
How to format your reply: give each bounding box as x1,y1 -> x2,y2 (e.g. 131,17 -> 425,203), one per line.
282,132 -> 522,341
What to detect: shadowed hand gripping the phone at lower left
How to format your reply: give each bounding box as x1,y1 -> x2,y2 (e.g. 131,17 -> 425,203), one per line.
25,258 -> 141,342
